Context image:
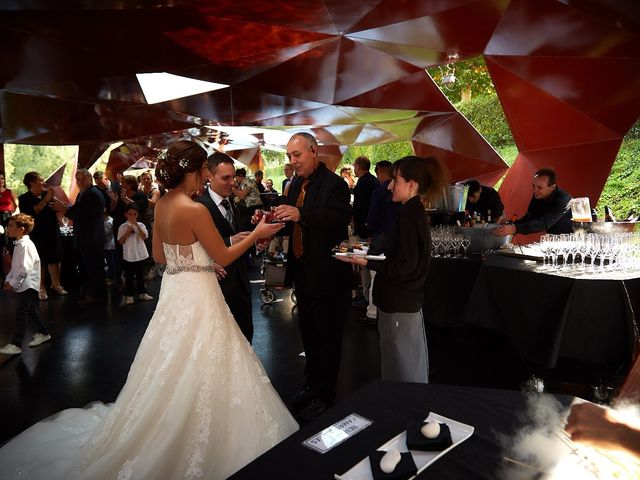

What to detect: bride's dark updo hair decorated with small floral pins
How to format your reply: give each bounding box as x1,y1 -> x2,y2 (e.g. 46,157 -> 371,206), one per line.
156,140 -> 207,188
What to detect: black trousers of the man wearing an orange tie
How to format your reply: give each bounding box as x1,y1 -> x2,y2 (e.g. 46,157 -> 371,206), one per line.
293,260 -> 351,402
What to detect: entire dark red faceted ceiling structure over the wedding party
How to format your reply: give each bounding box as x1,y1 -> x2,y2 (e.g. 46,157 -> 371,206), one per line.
0,0 -> 640,201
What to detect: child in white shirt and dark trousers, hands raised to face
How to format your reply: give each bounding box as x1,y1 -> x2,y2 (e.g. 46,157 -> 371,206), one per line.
118,203 -> 153,305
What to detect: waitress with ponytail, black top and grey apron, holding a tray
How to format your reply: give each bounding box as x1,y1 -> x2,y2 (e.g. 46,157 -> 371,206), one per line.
338,156 -> 448,383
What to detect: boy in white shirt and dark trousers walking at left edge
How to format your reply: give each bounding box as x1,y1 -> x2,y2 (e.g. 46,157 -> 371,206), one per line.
0,213 -> 51,355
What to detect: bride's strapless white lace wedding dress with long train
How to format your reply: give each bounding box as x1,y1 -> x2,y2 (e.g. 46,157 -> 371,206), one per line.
0,242 -> 298,480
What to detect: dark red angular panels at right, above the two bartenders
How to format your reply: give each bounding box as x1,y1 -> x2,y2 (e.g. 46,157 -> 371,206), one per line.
485,0 -> 640,215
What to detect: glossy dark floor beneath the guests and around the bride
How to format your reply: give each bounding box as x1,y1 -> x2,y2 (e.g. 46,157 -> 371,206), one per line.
0,258 -> 600,444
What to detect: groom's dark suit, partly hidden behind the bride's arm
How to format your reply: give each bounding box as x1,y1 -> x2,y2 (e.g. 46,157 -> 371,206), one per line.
197,190 -> 253,343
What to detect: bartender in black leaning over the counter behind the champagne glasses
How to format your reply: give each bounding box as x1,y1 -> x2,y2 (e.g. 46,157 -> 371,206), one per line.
493,168 -> 573,237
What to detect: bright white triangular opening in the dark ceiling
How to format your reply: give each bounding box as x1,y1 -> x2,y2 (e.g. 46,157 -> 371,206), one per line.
136,72 -> 228,104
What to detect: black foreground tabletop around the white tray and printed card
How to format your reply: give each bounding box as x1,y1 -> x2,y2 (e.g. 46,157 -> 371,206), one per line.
230,381 -> 573,480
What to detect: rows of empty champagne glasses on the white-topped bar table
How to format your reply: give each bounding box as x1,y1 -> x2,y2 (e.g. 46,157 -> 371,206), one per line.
540,232 -> 640,271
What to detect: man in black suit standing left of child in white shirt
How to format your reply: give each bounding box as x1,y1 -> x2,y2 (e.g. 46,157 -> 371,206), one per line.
65,169 -> 106,304
